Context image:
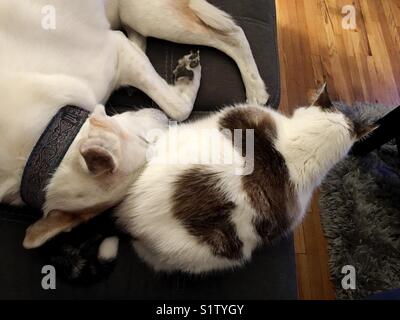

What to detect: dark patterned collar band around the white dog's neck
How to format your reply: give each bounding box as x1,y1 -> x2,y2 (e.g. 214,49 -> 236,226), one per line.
20,106 -> 89,210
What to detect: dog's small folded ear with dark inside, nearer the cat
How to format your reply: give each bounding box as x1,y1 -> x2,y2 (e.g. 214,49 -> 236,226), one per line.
80,138 -> 118,175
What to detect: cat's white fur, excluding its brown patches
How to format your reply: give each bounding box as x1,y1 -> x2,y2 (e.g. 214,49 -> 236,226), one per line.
116,105 -> 355,273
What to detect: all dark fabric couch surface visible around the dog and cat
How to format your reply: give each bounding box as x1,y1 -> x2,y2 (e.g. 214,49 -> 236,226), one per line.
0,0 -> 297,299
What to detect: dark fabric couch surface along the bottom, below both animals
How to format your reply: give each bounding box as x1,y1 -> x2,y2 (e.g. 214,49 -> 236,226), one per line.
0,208 -> 297,300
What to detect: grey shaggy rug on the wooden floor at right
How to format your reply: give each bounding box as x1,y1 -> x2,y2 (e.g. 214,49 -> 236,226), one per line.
320,105 -> 400,299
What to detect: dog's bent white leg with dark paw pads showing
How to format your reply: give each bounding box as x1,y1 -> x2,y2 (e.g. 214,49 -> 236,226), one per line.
114,32 -> 201,121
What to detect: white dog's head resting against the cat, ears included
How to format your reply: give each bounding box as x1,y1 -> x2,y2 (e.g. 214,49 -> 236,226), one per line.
24,106 -> 167,249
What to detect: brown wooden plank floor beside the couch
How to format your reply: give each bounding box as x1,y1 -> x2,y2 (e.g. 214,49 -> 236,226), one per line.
276,0 -> 400,299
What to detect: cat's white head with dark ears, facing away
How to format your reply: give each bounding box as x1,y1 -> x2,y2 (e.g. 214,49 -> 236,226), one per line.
280,85 -> 376,189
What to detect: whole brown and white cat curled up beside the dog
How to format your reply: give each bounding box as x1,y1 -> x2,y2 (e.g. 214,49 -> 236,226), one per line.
116,86 -> 372,274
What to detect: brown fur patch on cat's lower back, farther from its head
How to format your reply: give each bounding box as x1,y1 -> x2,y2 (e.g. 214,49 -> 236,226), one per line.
173,167 -> 243,260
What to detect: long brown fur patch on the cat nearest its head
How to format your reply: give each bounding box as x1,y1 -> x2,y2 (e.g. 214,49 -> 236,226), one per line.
220,108 -> 298,242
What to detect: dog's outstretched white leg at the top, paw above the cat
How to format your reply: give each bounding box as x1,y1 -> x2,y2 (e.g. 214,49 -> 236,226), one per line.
120,0 -> 269,104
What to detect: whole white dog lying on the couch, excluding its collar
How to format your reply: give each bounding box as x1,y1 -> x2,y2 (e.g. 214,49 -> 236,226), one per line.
0,0 -> 268,248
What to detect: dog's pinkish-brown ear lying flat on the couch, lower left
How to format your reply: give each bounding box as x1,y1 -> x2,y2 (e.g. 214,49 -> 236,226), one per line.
23,210 -> 83,249
